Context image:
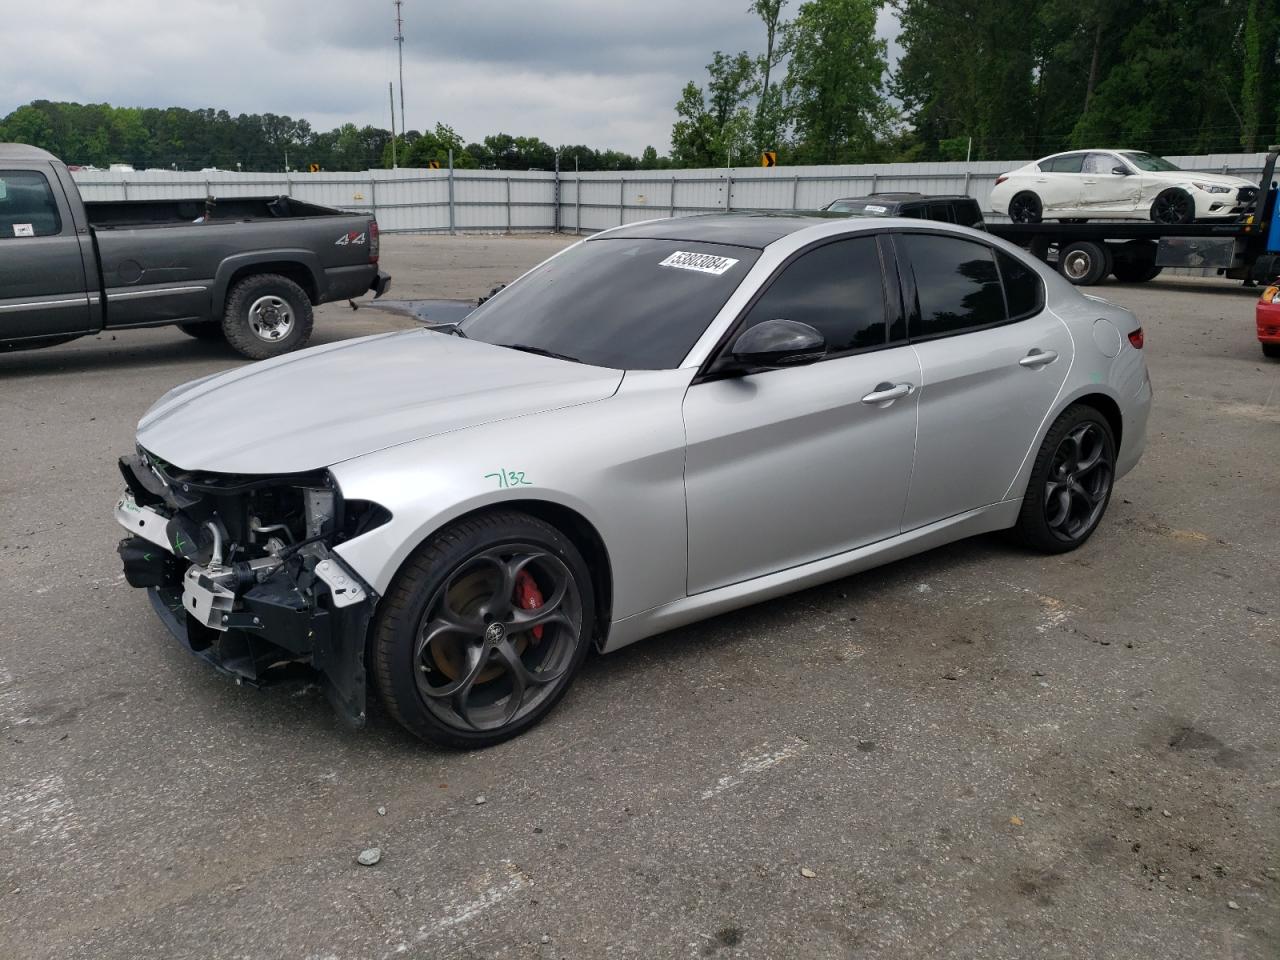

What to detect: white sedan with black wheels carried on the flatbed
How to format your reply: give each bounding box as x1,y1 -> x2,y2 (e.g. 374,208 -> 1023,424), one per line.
991,150 -> 1258,224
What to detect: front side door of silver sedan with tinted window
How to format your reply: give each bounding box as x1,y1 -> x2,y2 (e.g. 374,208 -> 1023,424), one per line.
684,234 -> 920,594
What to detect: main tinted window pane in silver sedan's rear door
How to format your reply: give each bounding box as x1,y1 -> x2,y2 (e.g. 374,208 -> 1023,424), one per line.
897,233 -> 1006,338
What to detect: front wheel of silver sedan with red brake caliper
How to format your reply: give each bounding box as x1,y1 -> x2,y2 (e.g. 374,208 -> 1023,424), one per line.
370,512 -> 595,749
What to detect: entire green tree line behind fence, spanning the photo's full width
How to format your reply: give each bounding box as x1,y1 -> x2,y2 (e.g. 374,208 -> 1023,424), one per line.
0,0 -> 1280,170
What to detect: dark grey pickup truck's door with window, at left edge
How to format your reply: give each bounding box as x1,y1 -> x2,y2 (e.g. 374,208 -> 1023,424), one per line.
0,164 -> 97,340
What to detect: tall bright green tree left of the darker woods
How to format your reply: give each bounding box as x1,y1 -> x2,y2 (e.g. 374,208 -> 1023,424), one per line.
785,0 -> 892,163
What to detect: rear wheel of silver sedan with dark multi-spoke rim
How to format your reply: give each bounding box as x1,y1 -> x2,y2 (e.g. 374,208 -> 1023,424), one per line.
1014,403 -> 1116,553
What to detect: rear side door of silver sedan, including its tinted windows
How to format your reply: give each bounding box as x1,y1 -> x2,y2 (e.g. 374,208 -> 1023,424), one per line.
893,232 -> 1074,530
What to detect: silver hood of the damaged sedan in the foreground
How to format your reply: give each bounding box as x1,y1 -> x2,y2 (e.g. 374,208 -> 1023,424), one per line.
138,330 -> 622,474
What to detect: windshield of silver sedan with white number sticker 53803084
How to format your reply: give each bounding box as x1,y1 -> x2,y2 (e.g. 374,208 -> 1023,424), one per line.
458,238 -> 760,370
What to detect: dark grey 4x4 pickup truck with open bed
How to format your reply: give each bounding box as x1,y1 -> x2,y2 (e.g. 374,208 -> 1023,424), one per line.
0,143 -> 390,360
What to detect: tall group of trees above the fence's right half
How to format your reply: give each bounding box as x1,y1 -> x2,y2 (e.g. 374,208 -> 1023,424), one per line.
671,0 -> 1280,166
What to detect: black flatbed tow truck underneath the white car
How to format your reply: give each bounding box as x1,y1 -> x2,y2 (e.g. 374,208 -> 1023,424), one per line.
987,146 -> 1280,285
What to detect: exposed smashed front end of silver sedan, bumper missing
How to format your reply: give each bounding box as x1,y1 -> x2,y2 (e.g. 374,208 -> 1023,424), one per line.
115,448 -> 389,727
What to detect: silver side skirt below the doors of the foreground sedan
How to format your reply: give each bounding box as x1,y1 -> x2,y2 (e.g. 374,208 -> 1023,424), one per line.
600,498 -> 1023,653
